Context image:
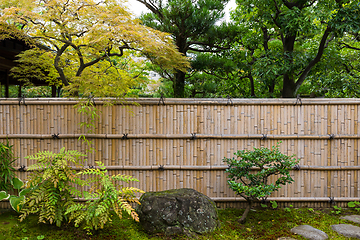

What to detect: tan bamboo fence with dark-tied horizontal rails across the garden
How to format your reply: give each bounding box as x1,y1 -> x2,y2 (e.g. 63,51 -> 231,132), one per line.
0,98 -> 360,207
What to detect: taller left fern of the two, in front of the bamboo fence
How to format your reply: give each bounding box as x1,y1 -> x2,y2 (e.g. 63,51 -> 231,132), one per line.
20,148 -> 86,227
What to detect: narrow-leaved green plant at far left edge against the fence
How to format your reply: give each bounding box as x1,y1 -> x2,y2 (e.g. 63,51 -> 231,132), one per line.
0,140 -> 16,191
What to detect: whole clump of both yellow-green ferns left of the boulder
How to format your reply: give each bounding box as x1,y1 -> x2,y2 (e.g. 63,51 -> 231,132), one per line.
20,148 -> 143,232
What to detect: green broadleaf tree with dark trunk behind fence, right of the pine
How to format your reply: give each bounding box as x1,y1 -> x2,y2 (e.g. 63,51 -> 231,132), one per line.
226,0 -> 360,97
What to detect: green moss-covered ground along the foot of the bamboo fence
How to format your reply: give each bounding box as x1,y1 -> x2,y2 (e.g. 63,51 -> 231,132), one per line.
0,208 -> 360,240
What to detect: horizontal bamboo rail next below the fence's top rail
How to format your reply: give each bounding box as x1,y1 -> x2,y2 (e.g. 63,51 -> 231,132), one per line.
0,133 -> 360,140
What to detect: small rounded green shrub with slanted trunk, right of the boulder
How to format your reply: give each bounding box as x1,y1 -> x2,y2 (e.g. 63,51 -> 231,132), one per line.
224,144 -> 298,223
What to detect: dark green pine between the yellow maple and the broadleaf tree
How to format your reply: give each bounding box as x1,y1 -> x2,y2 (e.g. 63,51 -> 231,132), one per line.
138,0 -> 237,97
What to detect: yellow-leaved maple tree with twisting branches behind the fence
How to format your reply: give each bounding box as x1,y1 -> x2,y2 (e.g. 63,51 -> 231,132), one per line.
0,0 -> 189,97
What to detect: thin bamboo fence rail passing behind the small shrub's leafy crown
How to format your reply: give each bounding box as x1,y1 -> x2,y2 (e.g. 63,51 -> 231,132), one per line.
15,165 -> 360,171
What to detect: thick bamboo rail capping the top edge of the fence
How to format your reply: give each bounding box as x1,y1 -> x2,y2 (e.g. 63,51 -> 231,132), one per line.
0,98 -> 360,106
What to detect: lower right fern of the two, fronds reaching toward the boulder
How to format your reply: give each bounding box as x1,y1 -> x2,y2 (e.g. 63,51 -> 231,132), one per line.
65,162 -> 144,232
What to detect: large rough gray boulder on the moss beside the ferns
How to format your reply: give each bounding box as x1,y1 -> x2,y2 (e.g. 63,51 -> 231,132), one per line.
136,188 -> 219,235
